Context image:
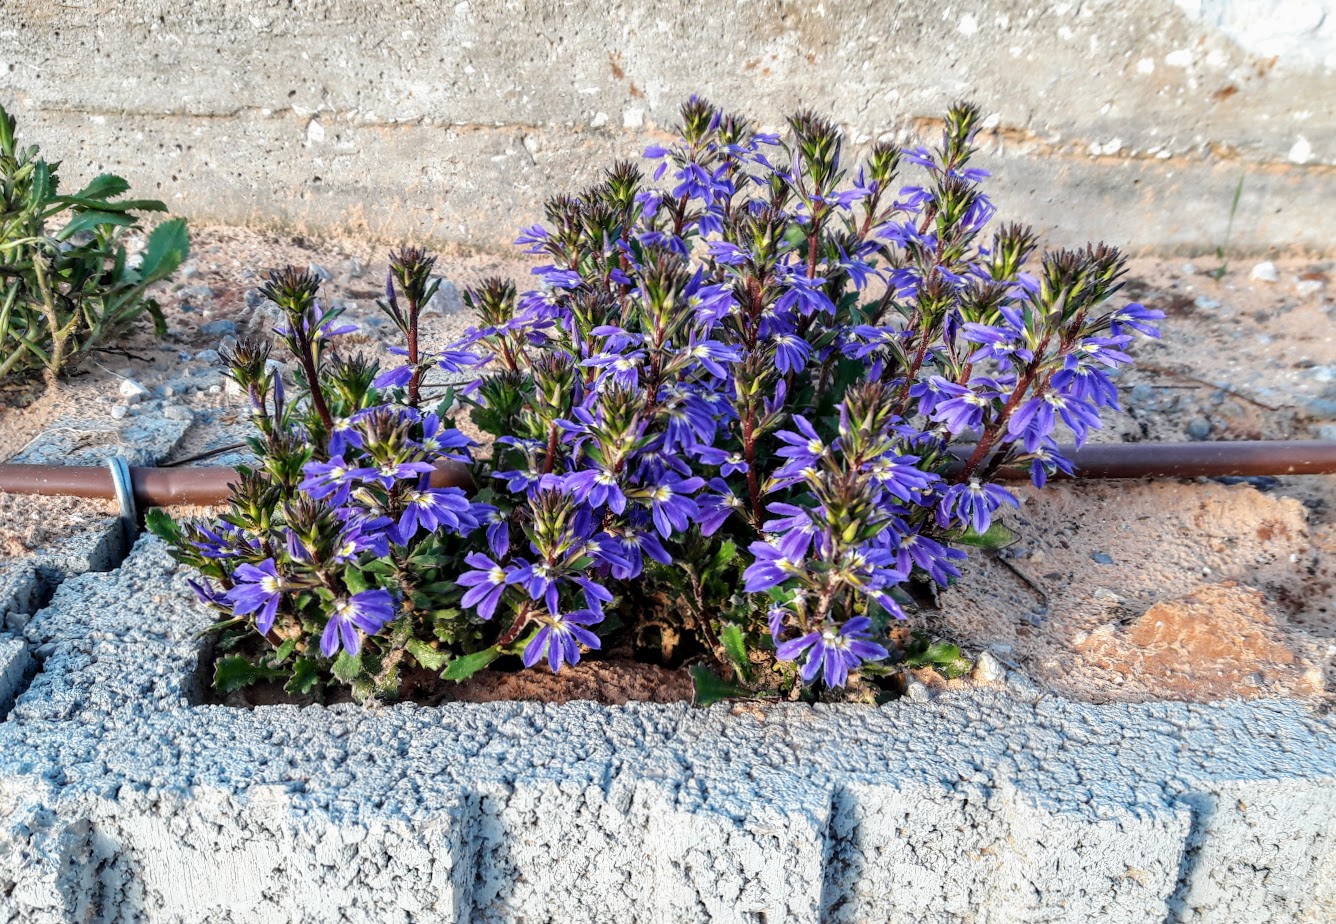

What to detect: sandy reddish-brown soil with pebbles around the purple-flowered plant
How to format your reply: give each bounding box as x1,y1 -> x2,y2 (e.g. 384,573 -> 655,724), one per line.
0,227 -> 1336,700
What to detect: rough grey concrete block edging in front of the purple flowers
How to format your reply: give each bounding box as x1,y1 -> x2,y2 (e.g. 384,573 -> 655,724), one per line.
0,539 -> 1336,924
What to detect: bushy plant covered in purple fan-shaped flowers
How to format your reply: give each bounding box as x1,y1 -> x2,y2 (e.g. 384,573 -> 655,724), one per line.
159,99 -> 1162,696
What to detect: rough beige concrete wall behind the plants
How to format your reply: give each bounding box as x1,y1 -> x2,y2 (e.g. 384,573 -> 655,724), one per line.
0,0 -> 1336,252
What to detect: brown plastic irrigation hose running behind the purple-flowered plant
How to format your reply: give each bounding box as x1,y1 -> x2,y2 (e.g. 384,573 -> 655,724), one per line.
0,439 -> 1336,510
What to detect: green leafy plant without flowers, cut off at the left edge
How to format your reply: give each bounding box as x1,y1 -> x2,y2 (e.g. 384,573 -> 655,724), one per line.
0,107 -> 190,381
